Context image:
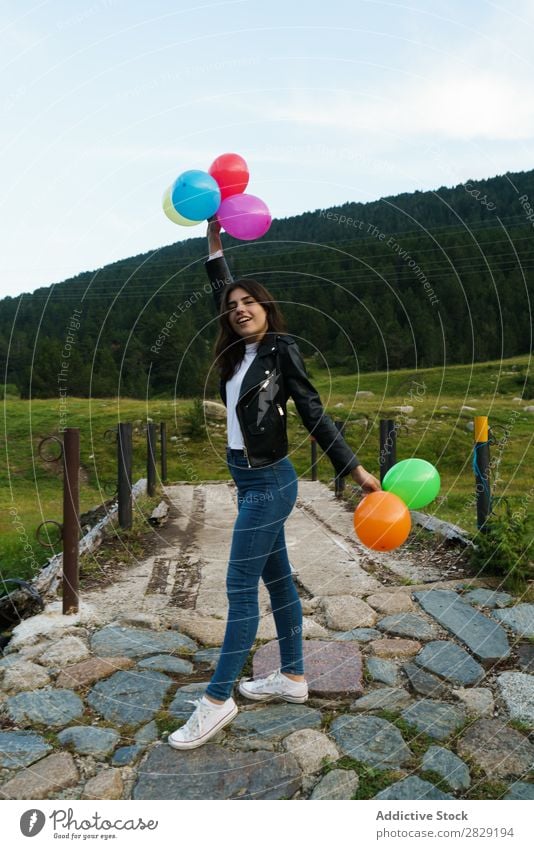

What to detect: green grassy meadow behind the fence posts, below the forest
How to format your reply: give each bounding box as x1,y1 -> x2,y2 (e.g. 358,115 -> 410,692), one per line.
0,356 -> 534,578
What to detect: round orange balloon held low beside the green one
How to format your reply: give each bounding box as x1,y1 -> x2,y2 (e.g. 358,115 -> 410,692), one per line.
354,492 -> 412,551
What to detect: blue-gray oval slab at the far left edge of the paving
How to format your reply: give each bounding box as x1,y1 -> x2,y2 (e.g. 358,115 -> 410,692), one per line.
6,690 -> 83,728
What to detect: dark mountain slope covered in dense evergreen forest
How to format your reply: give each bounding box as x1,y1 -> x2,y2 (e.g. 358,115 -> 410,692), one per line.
0,171 -> 534,398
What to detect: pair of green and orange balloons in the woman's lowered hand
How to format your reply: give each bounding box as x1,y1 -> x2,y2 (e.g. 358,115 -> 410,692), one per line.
354,457 -> 440,551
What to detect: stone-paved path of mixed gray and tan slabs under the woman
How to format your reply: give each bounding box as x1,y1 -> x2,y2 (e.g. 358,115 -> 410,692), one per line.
0,481 -> 534,799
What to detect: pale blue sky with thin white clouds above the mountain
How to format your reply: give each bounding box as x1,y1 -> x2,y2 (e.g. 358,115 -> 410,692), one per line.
0,0 -> 534,296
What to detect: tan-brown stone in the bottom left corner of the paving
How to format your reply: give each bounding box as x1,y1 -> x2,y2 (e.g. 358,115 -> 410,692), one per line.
0,752 -> 78,799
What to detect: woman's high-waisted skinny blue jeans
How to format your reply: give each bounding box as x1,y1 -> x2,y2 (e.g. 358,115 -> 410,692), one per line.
206,448 -> 304,700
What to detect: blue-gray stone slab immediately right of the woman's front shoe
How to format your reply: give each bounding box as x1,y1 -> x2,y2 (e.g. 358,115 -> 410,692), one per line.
228,704 -> 321,740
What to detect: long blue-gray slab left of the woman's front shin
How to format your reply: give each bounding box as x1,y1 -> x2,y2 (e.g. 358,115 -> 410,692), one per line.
91,625 -> 198,657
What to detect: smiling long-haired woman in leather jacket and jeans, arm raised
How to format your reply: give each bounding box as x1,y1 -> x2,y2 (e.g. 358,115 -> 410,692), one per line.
168,221 -> 380,749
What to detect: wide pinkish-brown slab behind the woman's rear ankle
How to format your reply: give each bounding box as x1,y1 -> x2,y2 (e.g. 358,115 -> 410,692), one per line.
252,640 -> 363,698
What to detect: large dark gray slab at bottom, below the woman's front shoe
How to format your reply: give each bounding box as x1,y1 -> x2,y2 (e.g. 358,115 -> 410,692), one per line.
133,743 -> 301,800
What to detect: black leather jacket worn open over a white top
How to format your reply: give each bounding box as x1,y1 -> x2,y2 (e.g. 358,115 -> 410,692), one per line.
206,257 -> 360,475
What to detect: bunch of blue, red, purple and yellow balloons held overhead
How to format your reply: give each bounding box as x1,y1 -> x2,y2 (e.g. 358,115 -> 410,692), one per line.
163,153 -> 271,241
